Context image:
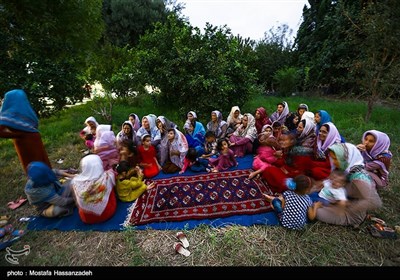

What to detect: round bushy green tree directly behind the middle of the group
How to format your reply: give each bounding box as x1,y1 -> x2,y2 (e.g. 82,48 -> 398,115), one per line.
125,15 -> 256,118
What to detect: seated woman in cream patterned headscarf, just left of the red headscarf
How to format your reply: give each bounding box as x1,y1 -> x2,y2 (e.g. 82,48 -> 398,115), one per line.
229,113 -> 257,157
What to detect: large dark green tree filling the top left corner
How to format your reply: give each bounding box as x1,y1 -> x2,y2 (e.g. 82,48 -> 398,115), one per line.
0,0 -> 103,114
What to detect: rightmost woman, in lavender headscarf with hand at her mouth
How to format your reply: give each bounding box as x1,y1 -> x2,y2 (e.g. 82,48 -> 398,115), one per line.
357,130 -> 392,188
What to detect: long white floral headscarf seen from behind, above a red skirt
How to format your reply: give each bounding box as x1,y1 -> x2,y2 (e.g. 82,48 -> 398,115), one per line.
71,154 -> 115,216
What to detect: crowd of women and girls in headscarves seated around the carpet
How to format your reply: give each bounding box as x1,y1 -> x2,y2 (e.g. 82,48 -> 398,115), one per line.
21,101 -> 391,230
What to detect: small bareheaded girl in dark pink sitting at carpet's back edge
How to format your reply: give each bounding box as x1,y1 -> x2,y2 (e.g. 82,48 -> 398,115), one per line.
207,139 -> 238,172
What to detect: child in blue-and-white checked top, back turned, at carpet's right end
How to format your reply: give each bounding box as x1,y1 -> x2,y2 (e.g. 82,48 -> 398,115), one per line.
263,175 -> 322,229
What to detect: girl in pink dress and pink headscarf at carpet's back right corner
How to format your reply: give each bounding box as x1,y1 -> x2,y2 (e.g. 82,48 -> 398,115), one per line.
249,124 -> 279,179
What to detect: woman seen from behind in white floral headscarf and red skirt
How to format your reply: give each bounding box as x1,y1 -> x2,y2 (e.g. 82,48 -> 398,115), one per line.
71,154 -> 117,224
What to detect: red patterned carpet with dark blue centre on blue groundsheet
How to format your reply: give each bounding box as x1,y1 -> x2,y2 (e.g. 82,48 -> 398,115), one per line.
129,169 -> 272,225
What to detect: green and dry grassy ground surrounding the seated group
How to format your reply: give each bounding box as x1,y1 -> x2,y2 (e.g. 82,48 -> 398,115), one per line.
0,93 -> 400,266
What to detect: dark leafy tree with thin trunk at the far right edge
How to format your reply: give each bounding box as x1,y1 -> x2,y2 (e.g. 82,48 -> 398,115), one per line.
347,0 -> 400,121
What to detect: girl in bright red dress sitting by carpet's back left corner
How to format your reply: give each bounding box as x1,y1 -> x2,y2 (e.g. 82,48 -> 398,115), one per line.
138,134 -> 161,178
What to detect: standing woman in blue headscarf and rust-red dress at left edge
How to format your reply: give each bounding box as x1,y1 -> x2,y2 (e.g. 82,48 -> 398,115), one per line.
0,89 -> 51,173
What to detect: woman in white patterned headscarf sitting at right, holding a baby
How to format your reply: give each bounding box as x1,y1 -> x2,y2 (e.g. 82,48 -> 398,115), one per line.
317,143 -> 382,226
